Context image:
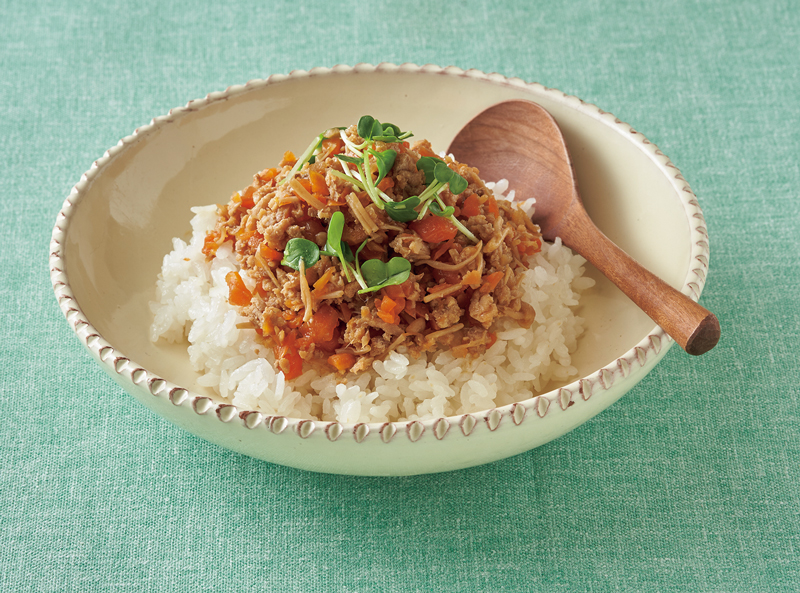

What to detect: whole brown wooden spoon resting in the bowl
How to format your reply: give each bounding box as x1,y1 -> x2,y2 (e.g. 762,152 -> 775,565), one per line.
449,101 -> 720,354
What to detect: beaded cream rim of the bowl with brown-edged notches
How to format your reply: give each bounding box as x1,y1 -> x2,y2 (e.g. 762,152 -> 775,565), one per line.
49,63 -> 709,443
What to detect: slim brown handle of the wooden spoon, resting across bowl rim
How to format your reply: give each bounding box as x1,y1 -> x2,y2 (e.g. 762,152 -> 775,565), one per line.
562,208 -> 720,355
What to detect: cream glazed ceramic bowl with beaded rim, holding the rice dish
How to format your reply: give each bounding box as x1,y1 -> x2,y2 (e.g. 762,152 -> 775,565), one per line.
50,64 -> 708,475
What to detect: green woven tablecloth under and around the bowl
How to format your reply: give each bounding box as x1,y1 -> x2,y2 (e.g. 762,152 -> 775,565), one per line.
0,0 -> 800,592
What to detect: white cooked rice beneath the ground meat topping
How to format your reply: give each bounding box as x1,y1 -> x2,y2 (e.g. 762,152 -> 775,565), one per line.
150,181 -> 594,423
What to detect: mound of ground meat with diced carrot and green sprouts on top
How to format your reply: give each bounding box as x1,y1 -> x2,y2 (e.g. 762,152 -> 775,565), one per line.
203,116 -> 541,379
